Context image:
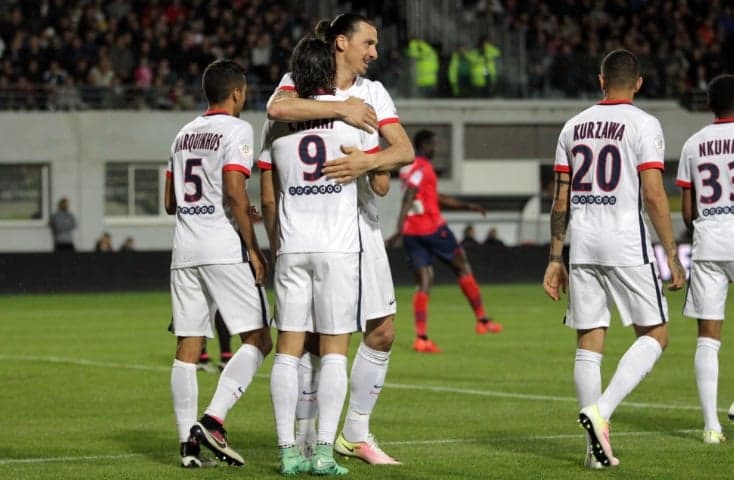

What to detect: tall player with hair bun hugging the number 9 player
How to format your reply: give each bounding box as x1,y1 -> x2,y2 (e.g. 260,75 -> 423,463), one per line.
268,13 -> 413,464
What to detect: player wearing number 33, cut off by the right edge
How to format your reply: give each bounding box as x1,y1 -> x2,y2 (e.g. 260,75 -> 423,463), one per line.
676,74 -> 734,443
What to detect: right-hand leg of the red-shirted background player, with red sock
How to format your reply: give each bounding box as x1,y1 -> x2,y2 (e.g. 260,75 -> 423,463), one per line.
432,225 -> 502,335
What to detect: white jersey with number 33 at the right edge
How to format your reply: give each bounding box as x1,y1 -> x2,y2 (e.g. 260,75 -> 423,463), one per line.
676,119 -> 734,261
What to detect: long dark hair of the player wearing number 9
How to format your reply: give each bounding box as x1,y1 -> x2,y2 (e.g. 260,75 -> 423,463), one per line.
291,36 -> 336,98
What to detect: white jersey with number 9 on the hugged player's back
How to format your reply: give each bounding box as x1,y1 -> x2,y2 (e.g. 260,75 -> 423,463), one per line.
258,95 -> 379,255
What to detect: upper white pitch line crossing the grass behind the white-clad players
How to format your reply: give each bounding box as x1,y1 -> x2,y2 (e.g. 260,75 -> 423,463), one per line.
0,354 -> 727,412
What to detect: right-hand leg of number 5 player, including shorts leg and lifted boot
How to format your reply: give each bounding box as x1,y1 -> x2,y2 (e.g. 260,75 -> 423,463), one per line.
191,263 -> 272,465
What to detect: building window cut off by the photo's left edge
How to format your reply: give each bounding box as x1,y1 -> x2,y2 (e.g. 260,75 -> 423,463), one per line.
0,163 -> 50,221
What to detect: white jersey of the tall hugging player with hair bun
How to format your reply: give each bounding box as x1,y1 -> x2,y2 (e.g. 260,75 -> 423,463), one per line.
276,73 -> 400,228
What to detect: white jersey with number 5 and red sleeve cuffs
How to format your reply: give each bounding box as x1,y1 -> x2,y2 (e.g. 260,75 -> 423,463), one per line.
166,111 -> 254,268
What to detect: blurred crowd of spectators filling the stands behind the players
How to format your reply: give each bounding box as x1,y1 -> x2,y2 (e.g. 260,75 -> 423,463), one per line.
0,0 -> 734,110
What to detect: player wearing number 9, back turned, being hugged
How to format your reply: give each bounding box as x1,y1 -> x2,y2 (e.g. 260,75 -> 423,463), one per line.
258,37 -> 379,475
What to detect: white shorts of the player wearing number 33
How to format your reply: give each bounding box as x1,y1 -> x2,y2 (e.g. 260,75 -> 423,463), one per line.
683,260 -> 734,320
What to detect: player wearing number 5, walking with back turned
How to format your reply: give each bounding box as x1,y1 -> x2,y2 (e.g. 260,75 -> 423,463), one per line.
165,60 -> 272,467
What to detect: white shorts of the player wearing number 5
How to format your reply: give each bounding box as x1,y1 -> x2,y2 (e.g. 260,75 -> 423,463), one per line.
171,262 -> 268,338
